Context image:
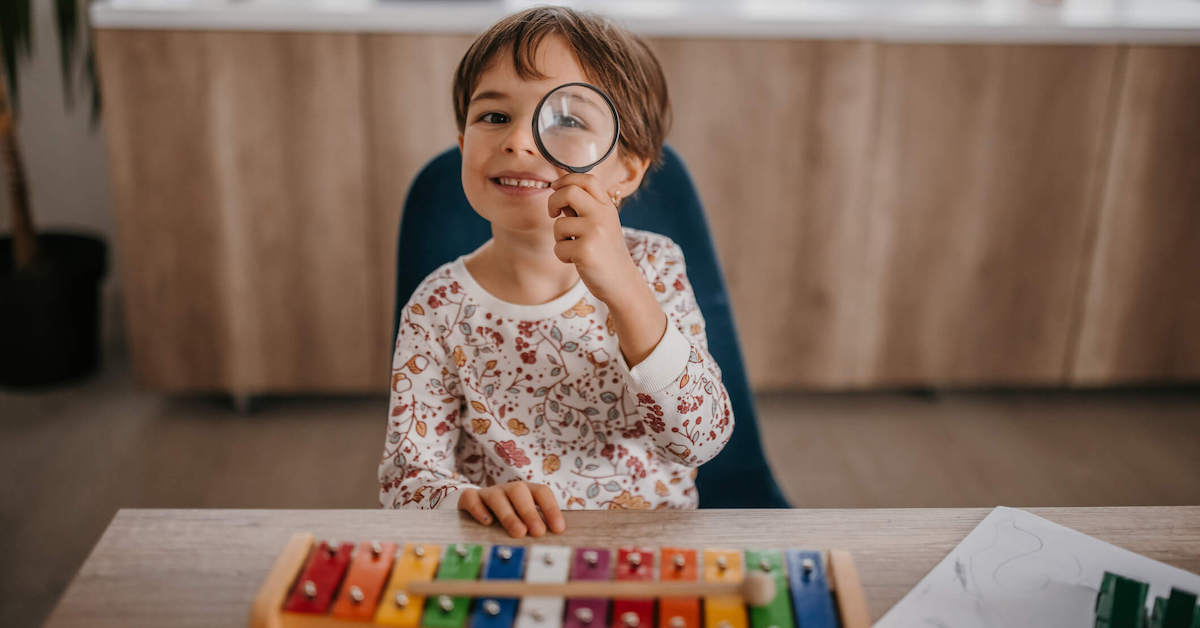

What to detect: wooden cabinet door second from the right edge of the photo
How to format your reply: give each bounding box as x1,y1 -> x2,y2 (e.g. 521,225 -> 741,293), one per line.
858,46 -> 1120,385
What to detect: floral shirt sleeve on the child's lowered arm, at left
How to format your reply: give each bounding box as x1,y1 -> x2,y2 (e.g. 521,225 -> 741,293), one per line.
379,282 -> 476,508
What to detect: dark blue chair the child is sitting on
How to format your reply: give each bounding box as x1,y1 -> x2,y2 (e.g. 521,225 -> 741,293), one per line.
392,146 -> 790,508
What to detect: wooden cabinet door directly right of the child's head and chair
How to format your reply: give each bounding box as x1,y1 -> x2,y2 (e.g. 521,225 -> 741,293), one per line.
653,38 -> 876,389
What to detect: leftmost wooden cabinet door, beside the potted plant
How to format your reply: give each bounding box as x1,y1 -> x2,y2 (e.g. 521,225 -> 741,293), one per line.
97,31 -> 379,394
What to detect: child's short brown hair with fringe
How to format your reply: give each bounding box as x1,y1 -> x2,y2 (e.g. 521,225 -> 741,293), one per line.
454,6 -> 671,171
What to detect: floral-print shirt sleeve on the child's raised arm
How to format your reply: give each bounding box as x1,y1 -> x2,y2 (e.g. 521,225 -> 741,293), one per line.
618,239 -> 733,467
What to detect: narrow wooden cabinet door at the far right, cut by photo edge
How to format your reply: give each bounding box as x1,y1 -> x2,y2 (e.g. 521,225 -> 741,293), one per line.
1069,47 -> 1200,385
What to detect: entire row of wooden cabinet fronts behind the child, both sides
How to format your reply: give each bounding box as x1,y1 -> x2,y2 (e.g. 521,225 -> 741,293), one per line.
97,30 -> 1200,394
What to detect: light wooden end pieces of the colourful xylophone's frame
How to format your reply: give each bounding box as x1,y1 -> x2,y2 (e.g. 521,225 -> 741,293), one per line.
250,532 -> 871,628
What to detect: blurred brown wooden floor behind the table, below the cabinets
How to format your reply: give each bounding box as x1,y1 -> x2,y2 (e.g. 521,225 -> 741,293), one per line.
0,360 -> 1200,626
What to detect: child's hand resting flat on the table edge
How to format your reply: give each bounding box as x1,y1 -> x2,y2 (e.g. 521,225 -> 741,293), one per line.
458,482 -> 566,538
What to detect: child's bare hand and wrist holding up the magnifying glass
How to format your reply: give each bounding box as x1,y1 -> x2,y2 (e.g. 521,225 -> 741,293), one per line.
547,174 -> 646,305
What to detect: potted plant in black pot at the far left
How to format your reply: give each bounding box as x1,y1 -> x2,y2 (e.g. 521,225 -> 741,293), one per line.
0,0 -> 107,387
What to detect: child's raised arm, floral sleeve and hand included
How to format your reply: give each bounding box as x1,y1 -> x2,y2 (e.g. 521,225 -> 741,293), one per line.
547,174 -> 733,467
